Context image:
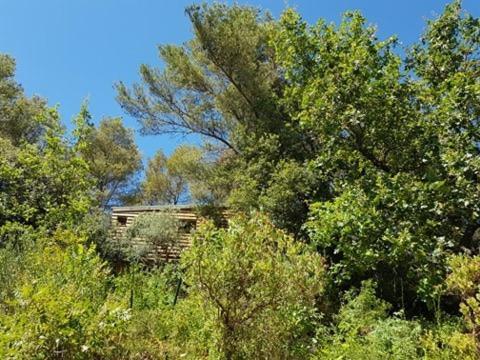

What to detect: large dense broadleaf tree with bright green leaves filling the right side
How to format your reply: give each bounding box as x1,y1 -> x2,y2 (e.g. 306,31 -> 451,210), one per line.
273,2 -> 480,313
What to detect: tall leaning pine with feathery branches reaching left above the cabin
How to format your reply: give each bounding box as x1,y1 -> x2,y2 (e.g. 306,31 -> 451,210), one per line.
117,4 -> 325,233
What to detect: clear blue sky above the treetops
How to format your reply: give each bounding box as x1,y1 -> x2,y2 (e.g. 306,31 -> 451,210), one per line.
0,0 -> 480,157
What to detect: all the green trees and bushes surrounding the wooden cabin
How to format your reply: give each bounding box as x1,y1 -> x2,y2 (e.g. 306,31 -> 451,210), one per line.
0,1 -> 480,360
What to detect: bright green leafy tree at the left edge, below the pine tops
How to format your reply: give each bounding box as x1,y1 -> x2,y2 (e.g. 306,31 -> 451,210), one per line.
0,109 -> 92,246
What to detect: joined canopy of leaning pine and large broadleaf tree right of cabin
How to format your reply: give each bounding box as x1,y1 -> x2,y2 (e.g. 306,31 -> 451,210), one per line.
117,1 -> 480,313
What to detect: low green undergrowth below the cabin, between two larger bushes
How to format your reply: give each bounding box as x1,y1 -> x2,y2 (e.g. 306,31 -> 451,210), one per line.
115,265 -> 205,359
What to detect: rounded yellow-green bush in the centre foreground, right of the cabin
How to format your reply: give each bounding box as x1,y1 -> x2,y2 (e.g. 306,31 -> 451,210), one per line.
182,214 -> 324,359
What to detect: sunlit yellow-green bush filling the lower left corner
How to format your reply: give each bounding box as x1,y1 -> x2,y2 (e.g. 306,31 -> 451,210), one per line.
0,233 -> 130,359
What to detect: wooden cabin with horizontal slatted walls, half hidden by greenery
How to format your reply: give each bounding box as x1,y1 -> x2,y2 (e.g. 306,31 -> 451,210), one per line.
111,205 -> 229,261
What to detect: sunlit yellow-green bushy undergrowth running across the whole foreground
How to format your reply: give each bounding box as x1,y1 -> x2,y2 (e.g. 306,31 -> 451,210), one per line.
0,221 -> 477,360
